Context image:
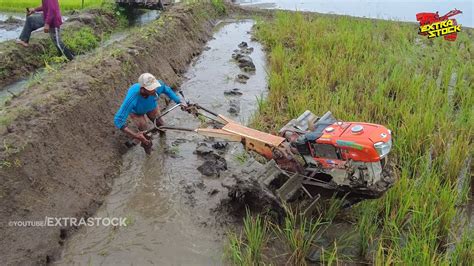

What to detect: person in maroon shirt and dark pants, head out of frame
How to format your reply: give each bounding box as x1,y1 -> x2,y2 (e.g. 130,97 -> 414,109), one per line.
17,0 -> 74,60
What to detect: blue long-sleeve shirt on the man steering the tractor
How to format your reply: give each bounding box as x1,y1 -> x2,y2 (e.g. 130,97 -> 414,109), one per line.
114,80 -> 181,129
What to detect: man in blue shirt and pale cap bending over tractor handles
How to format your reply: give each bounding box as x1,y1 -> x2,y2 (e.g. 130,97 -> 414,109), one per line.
114,73 -> 185,154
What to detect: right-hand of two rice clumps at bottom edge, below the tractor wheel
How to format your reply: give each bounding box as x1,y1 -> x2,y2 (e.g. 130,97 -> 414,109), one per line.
273,207 -> 323,265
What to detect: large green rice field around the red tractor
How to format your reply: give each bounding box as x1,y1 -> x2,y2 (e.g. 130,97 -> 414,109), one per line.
228,11 -> 474,265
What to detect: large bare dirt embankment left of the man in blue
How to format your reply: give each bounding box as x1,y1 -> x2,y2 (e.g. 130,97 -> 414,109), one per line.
0,4 -> 230,264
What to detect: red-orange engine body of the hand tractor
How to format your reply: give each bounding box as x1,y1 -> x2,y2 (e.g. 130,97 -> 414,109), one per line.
280,111 -> 393,197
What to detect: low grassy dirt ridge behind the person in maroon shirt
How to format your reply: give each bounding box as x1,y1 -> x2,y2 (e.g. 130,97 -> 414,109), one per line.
0,9 -> 118,87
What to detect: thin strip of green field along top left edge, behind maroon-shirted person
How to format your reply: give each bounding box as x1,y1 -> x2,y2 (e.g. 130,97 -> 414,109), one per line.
0,0 -> 104,12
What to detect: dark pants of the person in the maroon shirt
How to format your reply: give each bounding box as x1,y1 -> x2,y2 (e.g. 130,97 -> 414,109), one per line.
20,14 -> 74,60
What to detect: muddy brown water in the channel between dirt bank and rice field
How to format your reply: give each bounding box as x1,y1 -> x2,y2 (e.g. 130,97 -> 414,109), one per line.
57,21 -> 267,265
